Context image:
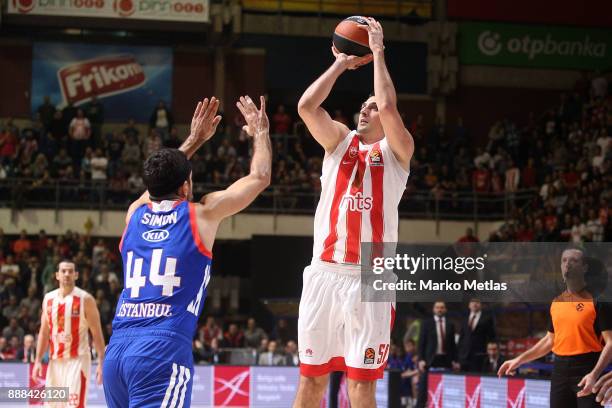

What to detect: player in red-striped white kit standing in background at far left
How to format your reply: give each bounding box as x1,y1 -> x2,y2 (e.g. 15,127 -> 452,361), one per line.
32,261 -> 104,407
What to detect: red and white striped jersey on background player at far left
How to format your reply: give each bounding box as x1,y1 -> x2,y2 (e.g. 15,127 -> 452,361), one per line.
43,287 -> 90,359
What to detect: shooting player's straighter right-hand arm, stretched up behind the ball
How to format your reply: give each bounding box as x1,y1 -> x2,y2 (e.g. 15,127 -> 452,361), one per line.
364,18 -> 414,170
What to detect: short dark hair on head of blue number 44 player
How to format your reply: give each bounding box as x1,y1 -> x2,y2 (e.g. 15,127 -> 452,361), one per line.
142,148 -> 191,197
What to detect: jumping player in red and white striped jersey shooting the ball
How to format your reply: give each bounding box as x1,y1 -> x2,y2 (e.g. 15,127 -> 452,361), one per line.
294,18 -> 414,408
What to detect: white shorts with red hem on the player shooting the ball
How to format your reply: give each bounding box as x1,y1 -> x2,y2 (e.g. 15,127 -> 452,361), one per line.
298,260 -> 395,381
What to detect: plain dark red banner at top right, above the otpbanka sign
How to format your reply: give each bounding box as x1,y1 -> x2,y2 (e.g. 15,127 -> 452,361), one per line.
447,0 -> 612,27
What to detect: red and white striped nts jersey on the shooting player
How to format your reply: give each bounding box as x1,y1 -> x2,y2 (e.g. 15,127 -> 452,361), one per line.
313,131 -> 409,264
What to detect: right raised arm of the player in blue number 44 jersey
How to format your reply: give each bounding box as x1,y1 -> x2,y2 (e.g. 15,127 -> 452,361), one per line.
201,96 -> 272,221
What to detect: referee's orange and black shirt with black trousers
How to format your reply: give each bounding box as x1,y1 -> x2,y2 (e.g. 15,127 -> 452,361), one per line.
548,291 -> 612,408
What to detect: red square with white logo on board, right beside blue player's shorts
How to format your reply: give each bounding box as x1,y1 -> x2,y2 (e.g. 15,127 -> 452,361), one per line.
214,366 -> 250,407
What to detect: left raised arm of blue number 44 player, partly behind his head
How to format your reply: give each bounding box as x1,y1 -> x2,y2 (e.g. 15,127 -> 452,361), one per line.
125,96 -> 221,224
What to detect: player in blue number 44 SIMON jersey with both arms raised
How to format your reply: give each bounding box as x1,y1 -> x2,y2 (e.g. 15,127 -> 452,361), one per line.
104,96 -> 271,408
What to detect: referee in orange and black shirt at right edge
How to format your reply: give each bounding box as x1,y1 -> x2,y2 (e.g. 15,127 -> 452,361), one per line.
497,249 -> 612,408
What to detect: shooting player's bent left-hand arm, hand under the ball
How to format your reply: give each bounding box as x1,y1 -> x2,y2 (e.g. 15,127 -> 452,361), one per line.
298,47 -> 372,153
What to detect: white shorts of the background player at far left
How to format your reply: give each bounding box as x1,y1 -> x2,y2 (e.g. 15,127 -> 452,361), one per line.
45,354 -> 91,408
